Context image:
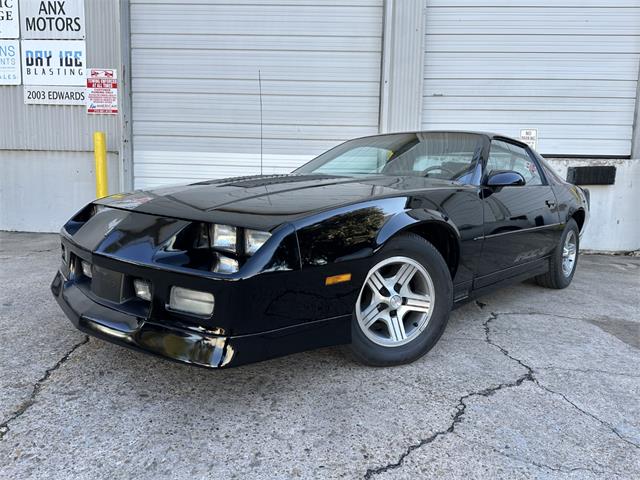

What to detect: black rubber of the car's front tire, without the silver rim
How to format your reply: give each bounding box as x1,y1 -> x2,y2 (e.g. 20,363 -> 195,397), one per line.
350,233 -> 453,367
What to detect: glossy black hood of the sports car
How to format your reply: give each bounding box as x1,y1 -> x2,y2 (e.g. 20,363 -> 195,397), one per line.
96,175 -> 460,230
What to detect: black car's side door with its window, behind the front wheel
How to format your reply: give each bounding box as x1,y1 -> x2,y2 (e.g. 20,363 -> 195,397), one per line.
476,139 -> 562,287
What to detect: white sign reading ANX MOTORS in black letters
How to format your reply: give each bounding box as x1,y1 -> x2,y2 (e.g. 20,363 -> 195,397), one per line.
19,0 -> 85,40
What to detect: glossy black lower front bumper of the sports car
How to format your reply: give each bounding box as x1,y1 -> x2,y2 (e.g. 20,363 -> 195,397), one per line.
51,271 -> 350,368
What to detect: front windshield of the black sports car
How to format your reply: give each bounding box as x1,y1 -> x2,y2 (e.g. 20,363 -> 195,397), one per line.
293,132 -> 483,183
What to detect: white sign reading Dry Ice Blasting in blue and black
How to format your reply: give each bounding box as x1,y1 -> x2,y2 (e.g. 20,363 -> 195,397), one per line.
22,40 -> 86,86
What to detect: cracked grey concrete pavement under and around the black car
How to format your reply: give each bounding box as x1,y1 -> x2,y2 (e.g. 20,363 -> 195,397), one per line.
0,232 -> 640,479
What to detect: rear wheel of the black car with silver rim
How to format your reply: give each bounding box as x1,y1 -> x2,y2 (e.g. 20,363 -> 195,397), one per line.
536,218 -> 580,289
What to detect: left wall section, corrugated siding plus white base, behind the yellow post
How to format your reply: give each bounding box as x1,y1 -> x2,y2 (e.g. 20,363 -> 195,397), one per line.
0,0 -> 121,232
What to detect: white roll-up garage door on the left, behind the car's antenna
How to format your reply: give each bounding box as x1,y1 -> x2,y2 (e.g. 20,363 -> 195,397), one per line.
131,0 -> 383,188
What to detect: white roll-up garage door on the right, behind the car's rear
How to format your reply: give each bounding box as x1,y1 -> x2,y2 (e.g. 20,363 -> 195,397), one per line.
422,0 -> 640,156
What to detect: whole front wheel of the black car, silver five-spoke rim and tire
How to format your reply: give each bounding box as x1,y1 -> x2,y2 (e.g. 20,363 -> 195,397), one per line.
351,233 -> 453,366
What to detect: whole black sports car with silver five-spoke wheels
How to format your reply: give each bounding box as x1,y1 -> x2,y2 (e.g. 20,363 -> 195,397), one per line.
51,131 -> 589,367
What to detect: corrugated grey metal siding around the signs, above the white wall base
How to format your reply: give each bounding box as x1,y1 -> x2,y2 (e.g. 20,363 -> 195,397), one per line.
0,0 -> 120,152
